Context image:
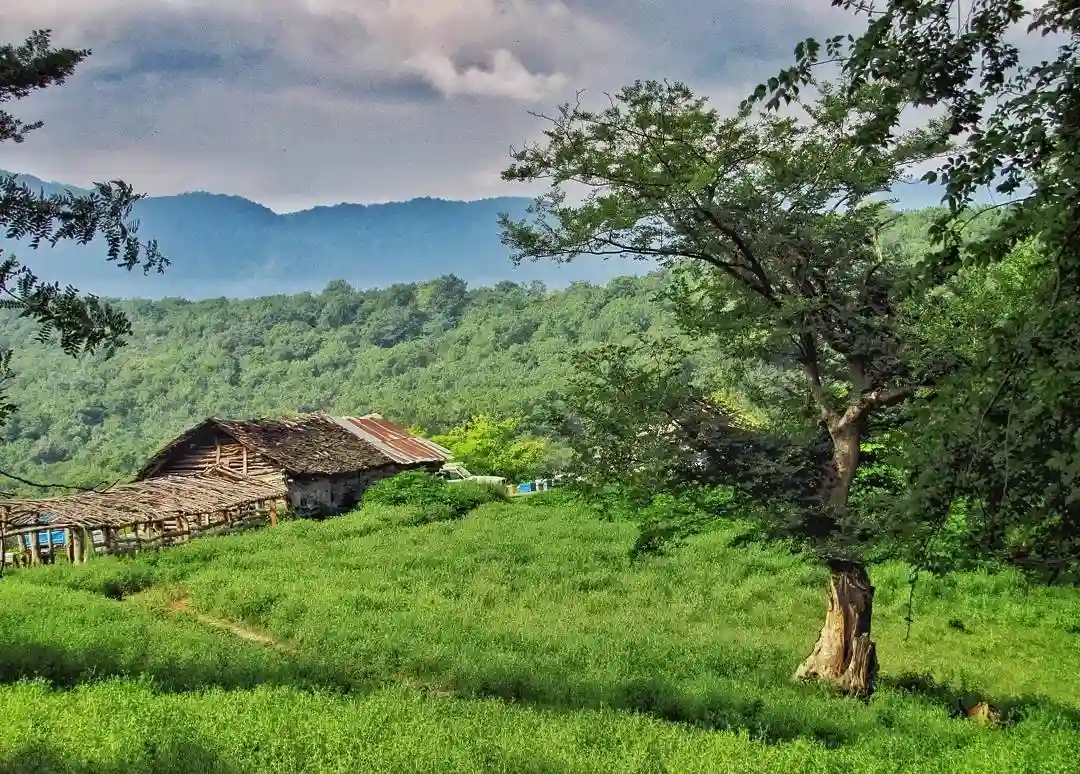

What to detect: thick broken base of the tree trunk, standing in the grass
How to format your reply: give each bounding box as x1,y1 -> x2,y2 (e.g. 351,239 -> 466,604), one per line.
795,561 -> 877,698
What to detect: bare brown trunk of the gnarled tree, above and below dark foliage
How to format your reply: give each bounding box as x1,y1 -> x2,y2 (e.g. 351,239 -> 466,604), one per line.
795,424 -> 877,698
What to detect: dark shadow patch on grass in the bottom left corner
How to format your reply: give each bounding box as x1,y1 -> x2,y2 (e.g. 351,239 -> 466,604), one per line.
0,739 -> 240,774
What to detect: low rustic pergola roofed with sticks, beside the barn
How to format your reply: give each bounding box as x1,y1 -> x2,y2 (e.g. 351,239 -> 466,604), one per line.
0,470 -> 287,563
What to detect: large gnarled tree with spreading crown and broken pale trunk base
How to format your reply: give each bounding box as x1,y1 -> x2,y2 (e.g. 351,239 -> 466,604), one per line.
502,82 -> 950,695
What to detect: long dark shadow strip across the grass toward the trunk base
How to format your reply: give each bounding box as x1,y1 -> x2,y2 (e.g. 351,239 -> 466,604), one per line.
0,641 -> 850,747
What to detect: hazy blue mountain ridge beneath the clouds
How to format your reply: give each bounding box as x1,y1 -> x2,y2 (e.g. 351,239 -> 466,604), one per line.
0,172 -> 646,299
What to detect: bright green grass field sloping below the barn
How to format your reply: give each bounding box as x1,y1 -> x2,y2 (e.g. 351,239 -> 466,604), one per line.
0,495 -> 1080,774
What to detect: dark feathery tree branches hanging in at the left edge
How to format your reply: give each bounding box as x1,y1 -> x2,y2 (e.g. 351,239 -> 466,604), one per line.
0,30 -> 168,438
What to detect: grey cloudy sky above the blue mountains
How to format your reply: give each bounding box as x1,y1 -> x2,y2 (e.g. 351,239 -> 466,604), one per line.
0,0 -> 852,211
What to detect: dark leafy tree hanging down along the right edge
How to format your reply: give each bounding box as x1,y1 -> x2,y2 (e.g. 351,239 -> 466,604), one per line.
754,0 -> 1080,579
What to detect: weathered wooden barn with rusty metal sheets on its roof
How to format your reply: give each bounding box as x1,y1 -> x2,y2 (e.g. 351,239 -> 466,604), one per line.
136,413 -> 450,516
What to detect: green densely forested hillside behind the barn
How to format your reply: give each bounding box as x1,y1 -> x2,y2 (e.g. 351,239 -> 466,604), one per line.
0,211 -> 972,492
